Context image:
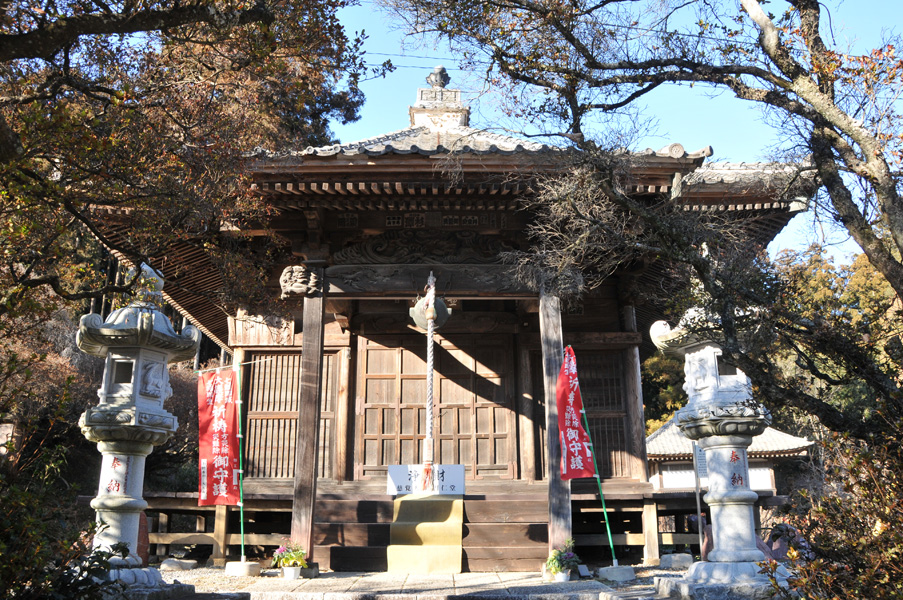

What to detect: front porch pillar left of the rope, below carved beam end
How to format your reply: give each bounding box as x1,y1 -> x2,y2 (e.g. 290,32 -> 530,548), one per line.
291,268 -> 326,560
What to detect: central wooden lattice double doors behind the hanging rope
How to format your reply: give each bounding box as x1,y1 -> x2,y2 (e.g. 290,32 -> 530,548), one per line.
355,335 -> 517,479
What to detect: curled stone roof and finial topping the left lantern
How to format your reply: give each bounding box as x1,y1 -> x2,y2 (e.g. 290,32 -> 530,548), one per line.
76,265 -> 201,362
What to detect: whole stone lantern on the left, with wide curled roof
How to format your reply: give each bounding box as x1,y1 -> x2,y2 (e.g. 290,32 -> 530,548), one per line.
76,265 -> 200,585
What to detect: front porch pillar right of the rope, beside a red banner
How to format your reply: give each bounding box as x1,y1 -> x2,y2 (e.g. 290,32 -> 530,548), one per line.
539,292 -> 571,549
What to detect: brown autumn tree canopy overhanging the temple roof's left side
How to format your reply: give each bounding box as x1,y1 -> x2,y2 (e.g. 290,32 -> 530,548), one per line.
0,0 -> 382,315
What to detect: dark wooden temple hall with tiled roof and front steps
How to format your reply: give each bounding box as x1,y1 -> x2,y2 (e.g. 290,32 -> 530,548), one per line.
147,68 -> 803,571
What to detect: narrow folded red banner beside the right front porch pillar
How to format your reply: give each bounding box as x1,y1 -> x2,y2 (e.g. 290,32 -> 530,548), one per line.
555,346 -> 596,480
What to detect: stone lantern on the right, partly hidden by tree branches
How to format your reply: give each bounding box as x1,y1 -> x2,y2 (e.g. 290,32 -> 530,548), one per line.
650,310 -> 771,597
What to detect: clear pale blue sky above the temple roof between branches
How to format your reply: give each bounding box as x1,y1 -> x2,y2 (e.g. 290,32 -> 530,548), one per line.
333,0 -> 903,262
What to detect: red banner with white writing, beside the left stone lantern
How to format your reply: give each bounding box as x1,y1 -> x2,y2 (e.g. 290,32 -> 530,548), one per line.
198,369 -> 239,506
